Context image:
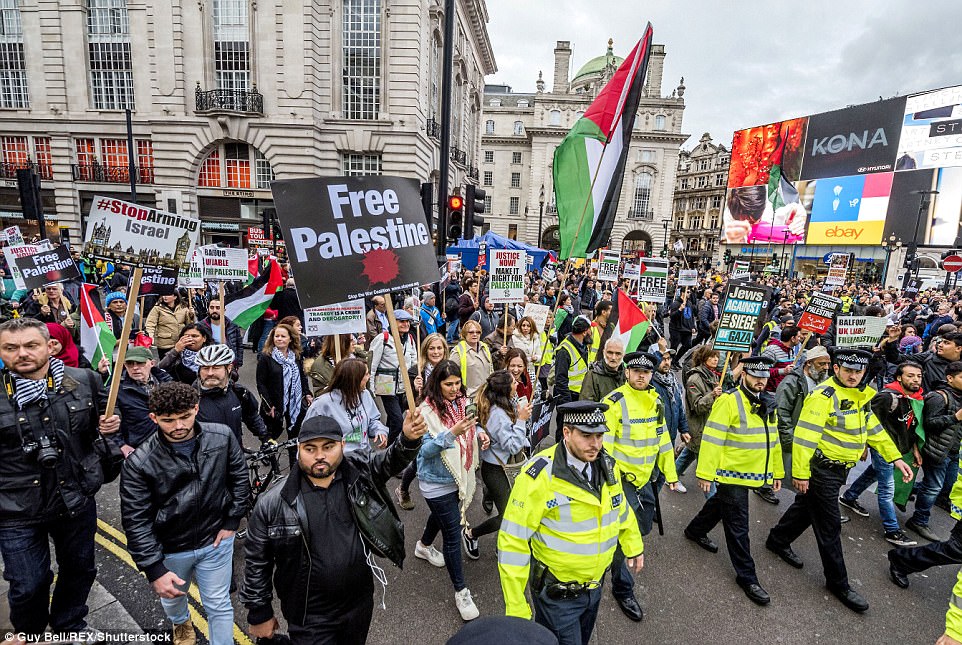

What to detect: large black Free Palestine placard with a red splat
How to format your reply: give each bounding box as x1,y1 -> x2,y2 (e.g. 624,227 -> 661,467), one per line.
271,175 -> 436,307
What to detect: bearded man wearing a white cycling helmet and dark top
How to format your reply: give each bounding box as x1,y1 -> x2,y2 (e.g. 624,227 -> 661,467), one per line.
194,345 -> 270,445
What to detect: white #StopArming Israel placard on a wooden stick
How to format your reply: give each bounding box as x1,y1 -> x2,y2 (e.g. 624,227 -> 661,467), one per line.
83,197 -> 200,269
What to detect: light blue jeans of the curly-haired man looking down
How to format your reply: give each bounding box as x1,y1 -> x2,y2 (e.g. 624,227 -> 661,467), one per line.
160,536 -> 234,645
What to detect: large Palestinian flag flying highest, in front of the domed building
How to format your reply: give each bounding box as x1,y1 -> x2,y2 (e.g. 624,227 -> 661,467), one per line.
554,23 -> 651,260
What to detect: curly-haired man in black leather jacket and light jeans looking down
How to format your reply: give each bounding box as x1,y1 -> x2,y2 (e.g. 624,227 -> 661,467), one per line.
120,382 -> 250,645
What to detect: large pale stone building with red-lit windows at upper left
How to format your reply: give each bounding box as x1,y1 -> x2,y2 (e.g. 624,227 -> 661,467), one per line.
0,0 -> 496,246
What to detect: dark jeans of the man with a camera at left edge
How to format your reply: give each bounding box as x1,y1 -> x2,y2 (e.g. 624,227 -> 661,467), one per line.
0,498 -> 97,634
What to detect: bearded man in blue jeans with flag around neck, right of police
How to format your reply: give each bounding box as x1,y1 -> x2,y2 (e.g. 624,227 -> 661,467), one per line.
838,362 -> 923,546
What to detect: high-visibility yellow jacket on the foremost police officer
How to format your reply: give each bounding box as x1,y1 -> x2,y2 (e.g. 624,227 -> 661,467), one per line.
498,442 -> 644,618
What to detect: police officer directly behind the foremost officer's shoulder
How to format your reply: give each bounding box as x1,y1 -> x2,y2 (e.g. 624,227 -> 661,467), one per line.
602,352 -> 678,622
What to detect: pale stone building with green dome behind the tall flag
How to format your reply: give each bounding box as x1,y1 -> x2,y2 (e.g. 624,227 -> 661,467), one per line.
480,40 -> 688,254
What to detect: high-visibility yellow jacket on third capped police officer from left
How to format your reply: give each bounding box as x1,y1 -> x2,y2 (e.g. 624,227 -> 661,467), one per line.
695,388 -> 785,488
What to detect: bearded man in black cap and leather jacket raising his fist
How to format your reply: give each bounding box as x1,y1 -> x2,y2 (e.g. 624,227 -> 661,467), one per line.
240,409 -> 427,645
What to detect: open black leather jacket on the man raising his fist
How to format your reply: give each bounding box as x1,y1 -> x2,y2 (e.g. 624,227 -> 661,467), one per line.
239,435 -> 421,625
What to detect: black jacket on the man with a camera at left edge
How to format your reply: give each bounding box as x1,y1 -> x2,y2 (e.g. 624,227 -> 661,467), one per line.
0,367 -> 107,526
